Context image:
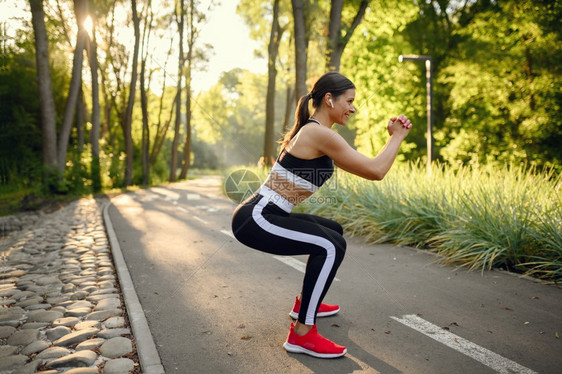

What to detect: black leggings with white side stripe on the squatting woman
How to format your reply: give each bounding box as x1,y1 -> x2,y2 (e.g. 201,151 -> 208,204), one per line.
232,194 -> 346,325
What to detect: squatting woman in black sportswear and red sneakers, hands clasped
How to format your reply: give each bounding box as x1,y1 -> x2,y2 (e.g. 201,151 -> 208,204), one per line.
232,72 -> 412,358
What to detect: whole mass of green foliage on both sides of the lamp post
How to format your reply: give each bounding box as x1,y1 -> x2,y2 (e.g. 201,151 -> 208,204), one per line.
342,0 -> 562,171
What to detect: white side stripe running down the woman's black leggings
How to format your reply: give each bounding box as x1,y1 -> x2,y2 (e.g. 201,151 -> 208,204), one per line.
252,197 -> 336,325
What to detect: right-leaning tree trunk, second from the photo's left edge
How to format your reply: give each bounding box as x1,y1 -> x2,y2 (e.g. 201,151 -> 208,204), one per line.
57,0 -> 88,175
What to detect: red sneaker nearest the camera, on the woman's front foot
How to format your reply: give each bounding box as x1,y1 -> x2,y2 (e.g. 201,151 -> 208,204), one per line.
283,323 -> 347,358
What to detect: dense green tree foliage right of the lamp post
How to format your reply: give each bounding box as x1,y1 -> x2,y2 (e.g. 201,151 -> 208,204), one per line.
439,1 -> 562,165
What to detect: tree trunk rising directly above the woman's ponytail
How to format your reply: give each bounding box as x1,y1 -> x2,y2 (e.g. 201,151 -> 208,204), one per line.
291,0 -> 308,100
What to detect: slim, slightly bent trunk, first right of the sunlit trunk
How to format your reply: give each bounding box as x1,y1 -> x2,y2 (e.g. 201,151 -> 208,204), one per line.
123,0 -> 140,187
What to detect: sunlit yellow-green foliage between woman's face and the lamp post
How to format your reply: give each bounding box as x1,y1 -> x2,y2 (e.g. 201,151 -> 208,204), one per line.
342,2 -> 425,159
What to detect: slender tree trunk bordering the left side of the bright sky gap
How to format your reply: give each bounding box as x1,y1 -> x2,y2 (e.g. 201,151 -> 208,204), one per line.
180,0 -> 195,179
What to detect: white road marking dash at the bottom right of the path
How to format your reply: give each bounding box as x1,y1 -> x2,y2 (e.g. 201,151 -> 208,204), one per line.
390,314 -> 536,374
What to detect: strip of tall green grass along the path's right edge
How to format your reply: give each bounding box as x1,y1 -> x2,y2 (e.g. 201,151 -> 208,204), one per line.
290,164 -> 562,282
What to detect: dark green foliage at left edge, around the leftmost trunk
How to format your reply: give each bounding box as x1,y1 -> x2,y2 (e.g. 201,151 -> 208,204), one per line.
0,17 -> 76,197
